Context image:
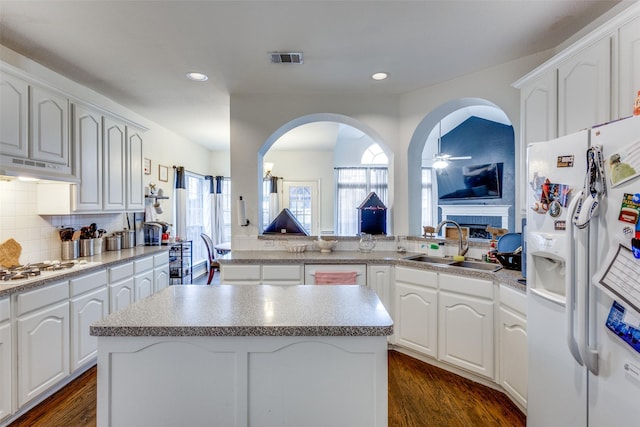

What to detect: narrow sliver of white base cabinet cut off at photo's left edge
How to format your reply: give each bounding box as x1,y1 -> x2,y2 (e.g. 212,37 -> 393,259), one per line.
0,297 -> 13,420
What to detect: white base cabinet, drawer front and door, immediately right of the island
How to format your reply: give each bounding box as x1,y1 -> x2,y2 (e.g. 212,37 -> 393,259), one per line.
394,266 -> 438,358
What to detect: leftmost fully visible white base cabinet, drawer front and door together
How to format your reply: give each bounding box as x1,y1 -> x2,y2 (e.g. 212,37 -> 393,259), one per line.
15,281 -> 70,408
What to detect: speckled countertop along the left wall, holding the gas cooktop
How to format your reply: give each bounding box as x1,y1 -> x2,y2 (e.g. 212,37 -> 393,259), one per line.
0,246 -> 169,297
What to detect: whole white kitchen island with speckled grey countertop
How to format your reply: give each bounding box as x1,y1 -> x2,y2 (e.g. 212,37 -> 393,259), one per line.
91,285 -> 393,427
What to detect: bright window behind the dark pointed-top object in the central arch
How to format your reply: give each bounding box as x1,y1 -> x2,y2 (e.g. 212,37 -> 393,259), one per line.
335,167 -> 388,236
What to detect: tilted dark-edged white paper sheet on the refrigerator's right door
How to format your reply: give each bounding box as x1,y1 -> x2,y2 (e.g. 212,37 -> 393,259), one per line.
600,245 -> 640,313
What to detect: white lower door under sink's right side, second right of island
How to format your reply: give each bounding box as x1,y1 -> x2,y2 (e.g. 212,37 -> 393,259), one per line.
438,292 -> 494,379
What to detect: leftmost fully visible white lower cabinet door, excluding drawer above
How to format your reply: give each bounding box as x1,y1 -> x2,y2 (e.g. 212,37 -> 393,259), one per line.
17,301 -> 70,407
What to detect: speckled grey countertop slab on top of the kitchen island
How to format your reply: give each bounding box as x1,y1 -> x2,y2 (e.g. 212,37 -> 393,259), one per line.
91,285 -> 393,337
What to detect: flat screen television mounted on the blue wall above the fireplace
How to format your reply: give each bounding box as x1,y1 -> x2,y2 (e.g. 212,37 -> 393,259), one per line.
436,163 -> 503,200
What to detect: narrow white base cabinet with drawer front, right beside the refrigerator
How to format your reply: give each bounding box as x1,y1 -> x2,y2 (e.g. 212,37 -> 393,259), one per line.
498,285 -> 528,408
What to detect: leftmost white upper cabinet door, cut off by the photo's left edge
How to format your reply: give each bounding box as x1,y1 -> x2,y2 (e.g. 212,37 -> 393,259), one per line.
0,72 -> 29,158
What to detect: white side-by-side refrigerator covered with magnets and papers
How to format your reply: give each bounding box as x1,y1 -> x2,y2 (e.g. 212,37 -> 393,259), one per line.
526,117 -> 640,427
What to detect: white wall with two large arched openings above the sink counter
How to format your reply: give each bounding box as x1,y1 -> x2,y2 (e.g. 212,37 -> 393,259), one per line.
231,52 -> 552,249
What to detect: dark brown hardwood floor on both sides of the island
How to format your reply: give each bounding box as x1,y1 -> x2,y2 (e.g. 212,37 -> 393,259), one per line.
11,351 -> 525,427
